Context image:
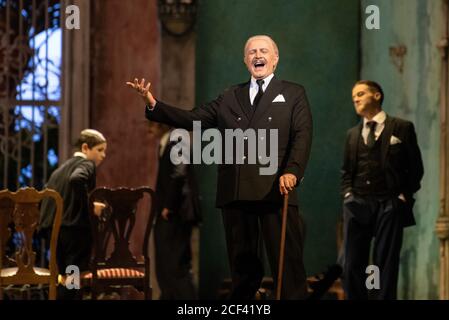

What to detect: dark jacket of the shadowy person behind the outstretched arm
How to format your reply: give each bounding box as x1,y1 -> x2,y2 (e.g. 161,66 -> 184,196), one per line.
156,142 -> 201,224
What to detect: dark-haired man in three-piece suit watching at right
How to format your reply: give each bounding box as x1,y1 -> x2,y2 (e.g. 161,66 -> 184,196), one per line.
341,80 -> 424,299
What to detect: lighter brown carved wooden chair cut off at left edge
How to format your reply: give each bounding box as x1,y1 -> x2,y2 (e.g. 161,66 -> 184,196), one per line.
0,188 -> 63,300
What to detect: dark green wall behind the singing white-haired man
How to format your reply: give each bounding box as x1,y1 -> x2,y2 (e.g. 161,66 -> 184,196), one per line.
196,0 -> 360,298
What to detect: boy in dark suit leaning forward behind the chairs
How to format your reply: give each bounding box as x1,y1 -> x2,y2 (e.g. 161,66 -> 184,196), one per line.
39,129 -> 107,300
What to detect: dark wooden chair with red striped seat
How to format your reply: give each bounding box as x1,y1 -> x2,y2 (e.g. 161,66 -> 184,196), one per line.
82,187 -> 155,300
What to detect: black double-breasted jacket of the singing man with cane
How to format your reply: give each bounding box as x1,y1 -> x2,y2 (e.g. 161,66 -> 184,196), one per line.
146,77 -> 312,207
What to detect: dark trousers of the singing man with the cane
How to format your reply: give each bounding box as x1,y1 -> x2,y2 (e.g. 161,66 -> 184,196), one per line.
223,202 -> 307,300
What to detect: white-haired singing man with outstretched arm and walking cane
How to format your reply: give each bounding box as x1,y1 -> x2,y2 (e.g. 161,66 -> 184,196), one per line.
127,35 -> 312,299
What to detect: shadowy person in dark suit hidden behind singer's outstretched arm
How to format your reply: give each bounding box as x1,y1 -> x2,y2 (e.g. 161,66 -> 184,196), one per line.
150,122 -> 201,300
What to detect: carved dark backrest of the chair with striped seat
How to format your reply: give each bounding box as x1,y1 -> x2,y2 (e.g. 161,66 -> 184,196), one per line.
89,187 -> 155,271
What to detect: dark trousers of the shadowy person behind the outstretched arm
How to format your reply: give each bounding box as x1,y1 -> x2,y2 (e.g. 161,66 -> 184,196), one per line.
154,214 -> 197,300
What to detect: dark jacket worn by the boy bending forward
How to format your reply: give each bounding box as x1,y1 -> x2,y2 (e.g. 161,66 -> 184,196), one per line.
39,157 -> 96,231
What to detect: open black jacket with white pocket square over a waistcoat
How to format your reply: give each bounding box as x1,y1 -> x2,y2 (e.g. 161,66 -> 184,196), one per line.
341,116 -> 424,226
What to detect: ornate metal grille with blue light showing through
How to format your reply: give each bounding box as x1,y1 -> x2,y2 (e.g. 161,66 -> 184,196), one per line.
0,0 -> 62,190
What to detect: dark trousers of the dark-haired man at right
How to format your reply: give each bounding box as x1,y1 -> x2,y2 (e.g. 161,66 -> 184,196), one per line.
343,195 -> 404,300
